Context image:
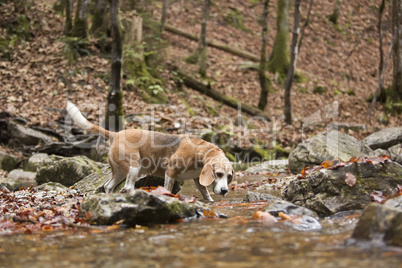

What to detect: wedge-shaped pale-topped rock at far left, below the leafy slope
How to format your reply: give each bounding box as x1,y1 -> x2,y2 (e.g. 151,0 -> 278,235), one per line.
7,120 -> 54,147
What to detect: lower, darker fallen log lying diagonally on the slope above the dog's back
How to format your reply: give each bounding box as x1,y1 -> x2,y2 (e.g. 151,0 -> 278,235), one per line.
167,65 -> 270,121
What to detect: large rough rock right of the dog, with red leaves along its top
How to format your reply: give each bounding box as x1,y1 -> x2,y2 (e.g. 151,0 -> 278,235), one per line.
282,160 -> 402,215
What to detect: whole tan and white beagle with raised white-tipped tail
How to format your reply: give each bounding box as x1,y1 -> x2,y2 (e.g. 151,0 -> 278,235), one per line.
66,101 -> 234,202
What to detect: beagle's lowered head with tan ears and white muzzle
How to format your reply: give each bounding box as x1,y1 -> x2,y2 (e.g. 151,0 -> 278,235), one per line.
200,158 -> 235,196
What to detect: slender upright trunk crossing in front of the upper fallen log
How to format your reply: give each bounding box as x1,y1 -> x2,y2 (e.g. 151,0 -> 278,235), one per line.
198,0 -> 210,77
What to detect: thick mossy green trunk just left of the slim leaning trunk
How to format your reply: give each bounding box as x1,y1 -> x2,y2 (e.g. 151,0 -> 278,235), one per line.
269,0 -> 290,75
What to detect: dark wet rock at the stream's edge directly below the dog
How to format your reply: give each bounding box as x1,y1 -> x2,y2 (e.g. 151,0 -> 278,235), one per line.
82,190 -> 204,226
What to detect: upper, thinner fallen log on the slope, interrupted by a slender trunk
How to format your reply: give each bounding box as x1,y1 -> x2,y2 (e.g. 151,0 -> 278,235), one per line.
165,24 -> 260,62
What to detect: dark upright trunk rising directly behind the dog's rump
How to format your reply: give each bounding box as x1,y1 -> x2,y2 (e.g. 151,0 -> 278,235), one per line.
105,0 -> 124,131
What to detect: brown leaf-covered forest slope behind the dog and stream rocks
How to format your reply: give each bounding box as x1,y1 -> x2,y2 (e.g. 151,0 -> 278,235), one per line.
0,0 -> 402,156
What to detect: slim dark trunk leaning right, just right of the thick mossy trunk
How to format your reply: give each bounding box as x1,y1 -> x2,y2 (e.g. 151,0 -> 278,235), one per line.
284,0 -> 301,125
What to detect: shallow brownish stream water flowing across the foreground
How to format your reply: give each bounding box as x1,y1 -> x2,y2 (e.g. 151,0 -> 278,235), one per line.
0,177 -> 402,268
